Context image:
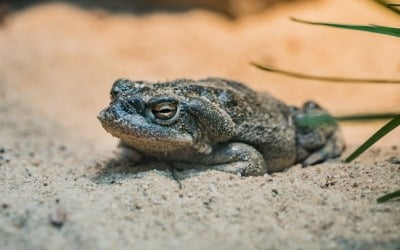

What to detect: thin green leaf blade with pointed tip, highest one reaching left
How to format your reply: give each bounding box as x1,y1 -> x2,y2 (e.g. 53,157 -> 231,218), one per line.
291,17 -> 400,37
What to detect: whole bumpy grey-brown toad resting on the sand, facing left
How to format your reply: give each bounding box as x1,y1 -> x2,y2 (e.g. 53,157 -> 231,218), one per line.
98,78 -> 344,175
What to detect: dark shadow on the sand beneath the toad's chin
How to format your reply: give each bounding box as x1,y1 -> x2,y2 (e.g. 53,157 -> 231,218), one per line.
92,147 -> 210,184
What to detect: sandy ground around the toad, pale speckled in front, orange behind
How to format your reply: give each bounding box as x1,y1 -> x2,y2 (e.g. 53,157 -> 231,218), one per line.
0,0 -> 400,249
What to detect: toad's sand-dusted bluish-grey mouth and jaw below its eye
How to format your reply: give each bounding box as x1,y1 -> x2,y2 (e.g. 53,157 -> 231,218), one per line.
97,105 -> 193,146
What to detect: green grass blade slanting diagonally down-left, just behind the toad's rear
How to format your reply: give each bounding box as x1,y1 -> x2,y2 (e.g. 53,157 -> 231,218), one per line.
345,115 -> 400,162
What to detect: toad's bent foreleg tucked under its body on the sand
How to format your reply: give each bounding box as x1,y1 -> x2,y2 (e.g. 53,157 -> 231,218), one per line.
201,143 -> 268,176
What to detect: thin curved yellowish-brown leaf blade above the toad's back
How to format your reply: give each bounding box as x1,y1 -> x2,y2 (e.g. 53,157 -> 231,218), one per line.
250,62 -> 400,84
